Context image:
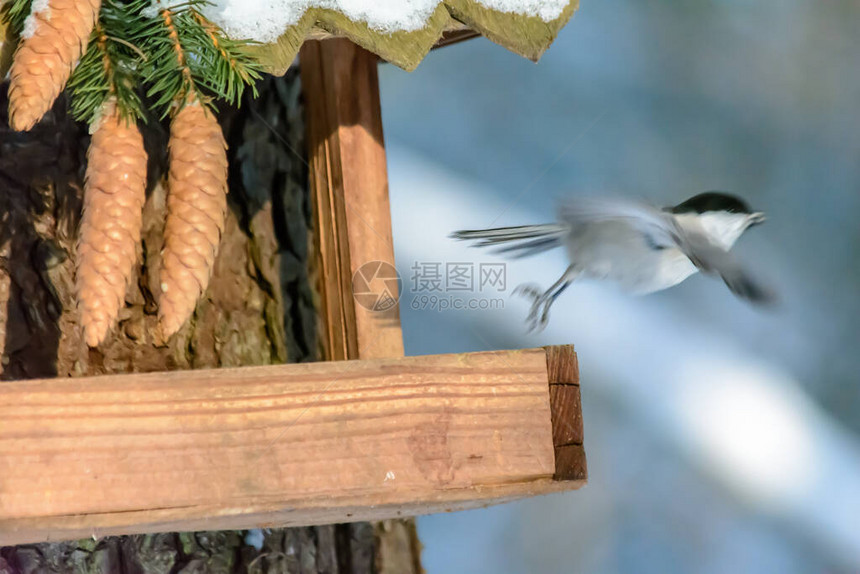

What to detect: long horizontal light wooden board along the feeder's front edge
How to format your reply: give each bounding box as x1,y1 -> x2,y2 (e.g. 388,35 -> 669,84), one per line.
0,349 -> 584,544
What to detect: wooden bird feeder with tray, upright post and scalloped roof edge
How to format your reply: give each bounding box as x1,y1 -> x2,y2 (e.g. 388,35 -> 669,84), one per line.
0,0 -> 587,560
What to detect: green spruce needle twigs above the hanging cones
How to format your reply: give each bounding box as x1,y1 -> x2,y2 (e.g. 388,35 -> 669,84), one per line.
5,0 -> 261,122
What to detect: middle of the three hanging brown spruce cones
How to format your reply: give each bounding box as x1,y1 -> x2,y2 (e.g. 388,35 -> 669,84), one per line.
76,104 -> 146,347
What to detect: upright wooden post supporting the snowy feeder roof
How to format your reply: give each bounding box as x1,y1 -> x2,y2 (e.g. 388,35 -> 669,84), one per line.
300,39 -> 403,360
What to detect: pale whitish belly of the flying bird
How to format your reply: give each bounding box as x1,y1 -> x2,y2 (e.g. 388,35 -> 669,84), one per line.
568,224 -> 697,295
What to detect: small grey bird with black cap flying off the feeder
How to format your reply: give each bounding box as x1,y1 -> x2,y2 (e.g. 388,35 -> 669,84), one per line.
451,191 -> 775,330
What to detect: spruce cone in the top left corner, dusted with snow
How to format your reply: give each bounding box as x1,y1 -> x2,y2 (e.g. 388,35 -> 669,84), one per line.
9,0 -> 101,131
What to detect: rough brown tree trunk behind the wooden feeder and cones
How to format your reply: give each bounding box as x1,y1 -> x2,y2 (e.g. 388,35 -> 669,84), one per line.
0,70 -> 421,574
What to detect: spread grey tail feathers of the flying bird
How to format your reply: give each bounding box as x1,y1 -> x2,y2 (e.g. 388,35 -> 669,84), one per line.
451,223 -> 568,258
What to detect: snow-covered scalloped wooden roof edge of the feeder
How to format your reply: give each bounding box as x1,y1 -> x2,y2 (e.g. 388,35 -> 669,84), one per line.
201,0 -> 579,73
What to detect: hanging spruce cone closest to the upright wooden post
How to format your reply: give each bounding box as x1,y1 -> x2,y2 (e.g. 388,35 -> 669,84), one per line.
158,102 -> 227,337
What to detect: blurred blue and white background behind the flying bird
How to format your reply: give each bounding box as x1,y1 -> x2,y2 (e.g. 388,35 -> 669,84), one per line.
381,0 -> 860,574
